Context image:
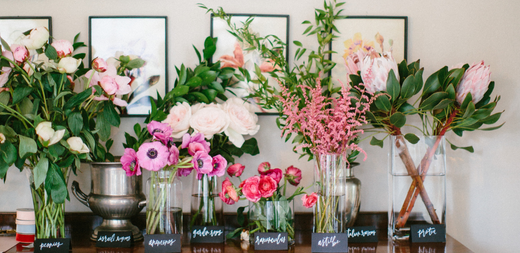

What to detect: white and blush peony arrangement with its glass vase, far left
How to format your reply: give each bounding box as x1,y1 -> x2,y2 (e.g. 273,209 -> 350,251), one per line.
0,27 -> 142,239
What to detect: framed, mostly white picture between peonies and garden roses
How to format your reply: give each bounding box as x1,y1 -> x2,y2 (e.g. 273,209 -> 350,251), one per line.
89,16 -> 168,116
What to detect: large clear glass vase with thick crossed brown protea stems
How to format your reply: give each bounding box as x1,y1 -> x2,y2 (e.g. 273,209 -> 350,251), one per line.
388,135 -> 446,240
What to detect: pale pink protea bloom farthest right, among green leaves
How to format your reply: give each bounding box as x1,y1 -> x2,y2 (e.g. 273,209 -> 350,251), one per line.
457,61 -> 491,104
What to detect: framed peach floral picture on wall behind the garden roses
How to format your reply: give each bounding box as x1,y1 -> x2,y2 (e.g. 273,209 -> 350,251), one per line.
211,13 -> 289,115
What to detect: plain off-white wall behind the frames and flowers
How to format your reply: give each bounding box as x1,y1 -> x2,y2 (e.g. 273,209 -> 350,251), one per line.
0,0 -> 520,252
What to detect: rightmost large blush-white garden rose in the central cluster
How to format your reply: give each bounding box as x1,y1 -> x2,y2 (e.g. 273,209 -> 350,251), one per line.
224,97 -> 260,147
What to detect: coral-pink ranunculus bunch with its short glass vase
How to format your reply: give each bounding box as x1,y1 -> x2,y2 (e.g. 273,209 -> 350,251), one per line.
219,162 -> 316,240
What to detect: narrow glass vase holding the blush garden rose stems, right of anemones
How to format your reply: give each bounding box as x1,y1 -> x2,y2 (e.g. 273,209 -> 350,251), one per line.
190,174 -> 224,227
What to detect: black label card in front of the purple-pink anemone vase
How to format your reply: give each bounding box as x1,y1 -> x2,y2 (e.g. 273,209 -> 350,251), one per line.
144,234 -> 182,253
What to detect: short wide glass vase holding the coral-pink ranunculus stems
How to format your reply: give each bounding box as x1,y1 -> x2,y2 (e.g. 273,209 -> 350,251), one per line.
249,199 -> 294,245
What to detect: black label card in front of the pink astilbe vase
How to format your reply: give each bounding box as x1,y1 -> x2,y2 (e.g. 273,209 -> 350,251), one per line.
311,233 -> 348,252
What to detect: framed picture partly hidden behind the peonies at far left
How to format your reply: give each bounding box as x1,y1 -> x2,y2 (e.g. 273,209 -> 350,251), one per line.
0,17 -> 52,45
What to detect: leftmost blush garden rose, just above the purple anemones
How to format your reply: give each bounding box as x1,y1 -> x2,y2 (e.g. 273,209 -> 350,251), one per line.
163,102 -> 191,139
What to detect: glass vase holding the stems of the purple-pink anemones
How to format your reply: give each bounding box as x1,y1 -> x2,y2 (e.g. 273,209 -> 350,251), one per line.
146,170 -> 183,235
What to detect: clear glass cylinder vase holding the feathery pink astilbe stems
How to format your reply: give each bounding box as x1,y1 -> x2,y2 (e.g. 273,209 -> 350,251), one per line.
314,154 -> 346,233
